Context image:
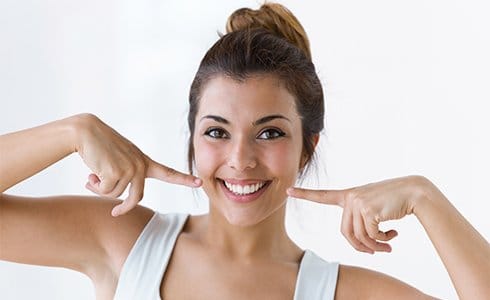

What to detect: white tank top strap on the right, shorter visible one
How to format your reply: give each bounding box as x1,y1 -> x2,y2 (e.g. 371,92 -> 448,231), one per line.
294,250 -> 339,300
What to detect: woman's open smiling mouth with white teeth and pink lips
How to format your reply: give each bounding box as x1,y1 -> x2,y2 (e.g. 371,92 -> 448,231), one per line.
219,179 -> 271,203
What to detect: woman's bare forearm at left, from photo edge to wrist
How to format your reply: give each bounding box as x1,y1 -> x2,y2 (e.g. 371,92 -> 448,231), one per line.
0,116 -> 79,192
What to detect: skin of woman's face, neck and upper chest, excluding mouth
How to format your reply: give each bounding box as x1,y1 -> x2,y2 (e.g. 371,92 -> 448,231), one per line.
161,77 -> 302,299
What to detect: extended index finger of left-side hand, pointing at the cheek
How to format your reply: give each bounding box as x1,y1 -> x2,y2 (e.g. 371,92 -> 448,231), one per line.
146,160 -> 202,187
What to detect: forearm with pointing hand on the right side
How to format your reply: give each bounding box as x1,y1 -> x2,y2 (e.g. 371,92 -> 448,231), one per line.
288,176 -> 490,299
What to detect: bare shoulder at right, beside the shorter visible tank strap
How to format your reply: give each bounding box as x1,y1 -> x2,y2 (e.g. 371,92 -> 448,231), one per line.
335,265 -> 436,299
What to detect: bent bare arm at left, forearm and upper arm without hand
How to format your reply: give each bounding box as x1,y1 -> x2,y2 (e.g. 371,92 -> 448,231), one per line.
0,115 -> 151,276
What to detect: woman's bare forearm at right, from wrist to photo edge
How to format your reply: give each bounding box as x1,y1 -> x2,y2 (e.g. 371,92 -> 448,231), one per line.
414,180 -> 490,299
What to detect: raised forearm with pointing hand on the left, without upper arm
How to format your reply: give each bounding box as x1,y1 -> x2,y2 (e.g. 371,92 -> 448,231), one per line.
0,114 -> 200,216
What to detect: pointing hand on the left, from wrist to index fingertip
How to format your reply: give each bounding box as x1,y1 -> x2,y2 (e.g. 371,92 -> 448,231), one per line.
76,114 -> 202,216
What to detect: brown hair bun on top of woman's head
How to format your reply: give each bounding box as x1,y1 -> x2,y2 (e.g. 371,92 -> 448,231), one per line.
226,3 -> 311,60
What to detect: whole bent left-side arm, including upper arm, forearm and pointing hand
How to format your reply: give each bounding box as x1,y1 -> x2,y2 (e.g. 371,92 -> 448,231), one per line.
0,114 -> 196,275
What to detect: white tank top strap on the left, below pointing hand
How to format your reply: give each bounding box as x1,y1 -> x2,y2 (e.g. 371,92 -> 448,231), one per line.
114,212 -> 188,300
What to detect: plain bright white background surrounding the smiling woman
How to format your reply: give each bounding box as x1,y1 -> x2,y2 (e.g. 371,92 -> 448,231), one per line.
0,0 -> 490,300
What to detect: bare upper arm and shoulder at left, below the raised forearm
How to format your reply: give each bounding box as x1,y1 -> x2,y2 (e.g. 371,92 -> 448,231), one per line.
0,194 -> 154,280
